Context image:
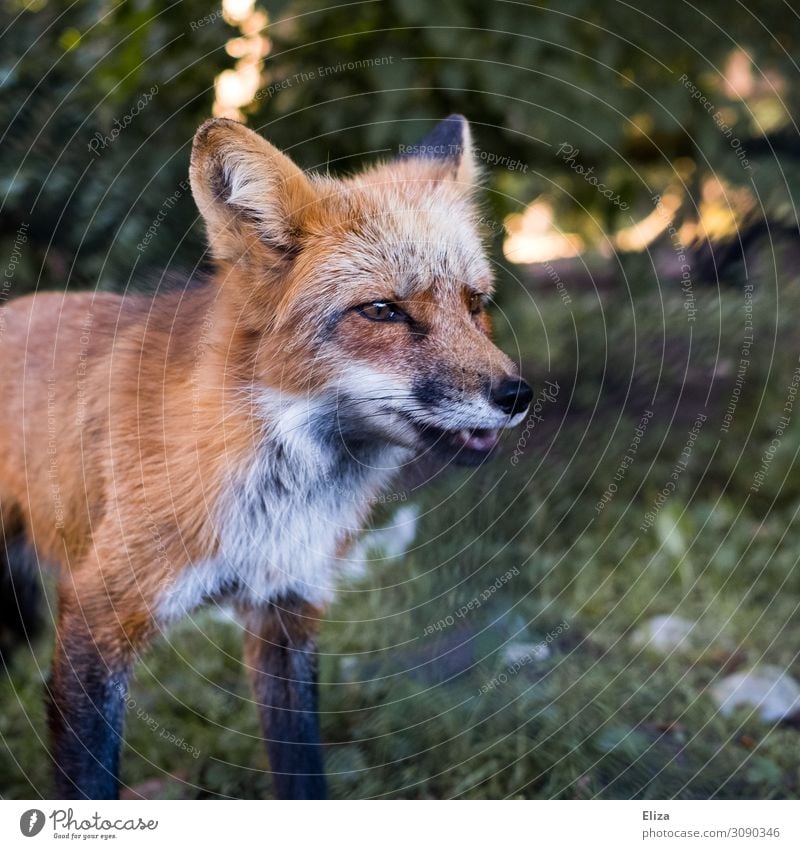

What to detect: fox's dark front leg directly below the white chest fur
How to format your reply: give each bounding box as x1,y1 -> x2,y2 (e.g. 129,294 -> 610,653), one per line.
243,596 -> 325,799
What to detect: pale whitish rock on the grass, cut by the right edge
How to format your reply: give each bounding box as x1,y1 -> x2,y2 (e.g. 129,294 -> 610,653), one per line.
711,666 -> 800,722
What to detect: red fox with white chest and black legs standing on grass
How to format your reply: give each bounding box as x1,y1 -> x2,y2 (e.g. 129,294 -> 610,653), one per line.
0,115 -> 533,799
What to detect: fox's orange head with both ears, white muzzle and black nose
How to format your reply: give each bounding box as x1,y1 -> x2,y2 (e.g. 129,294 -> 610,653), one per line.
190,115 -> 532,463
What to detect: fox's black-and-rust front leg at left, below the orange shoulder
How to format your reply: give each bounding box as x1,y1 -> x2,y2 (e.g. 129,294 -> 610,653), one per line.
48,589 -> 147,799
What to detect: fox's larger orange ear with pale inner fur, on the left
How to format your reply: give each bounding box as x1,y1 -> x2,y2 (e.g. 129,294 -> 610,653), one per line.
189,118 -> 316,260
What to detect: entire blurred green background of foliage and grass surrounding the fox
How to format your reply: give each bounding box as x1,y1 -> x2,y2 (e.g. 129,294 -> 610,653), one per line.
0,0 -> 800,799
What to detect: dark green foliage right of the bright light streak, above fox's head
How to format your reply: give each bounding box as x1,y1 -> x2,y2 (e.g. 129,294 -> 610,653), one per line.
252,0 -> 800,236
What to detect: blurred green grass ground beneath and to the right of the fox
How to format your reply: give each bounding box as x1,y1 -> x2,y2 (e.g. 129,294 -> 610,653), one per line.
0,268 -> 800,799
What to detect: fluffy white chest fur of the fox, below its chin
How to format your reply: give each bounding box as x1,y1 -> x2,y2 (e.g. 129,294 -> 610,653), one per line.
159,410 -> 404,621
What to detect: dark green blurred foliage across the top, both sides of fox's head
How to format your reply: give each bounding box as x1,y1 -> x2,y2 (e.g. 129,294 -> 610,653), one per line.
0,0 -> 800,288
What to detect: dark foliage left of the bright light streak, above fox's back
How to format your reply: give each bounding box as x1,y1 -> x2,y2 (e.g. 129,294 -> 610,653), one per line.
0,0 -> 234,294
